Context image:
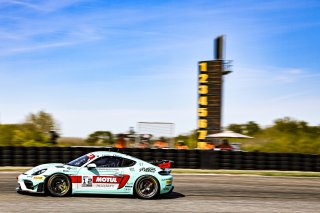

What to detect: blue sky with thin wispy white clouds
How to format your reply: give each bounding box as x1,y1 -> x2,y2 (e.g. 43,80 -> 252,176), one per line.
0,0 -> 320,137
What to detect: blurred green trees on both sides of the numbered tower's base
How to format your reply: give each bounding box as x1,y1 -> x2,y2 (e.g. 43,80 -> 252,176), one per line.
175,117 -> 320,154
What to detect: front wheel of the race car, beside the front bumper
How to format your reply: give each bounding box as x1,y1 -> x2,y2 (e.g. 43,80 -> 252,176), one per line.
46,174 -> 71,197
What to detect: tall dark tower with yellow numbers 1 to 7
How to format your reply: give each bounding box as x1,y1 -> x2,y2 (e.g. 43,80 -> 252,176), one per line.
197,36 -> 231,149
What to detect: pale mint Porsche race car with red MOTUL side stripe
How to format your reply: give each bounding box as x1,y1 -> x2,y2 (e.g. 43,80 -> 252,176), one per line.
16,151 -> 174,199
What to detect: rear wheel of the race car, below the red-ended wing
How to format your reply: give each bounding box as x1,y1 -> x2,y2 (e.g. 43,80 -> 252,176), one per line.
134,175 -> 160,199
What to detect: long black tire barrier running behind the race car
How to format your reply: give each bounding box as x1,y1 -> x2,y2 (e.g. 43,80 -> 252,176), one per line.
0,146 -> 320,171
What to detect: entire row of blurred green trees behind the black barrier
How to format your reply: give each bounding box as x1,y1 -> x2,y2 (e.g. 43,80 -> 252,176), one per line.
0,111 -> 320,154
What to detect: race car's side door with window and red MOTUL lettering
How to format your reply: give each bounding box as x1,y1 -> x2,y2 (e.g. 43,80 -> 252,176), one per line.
78,156 -> 130,194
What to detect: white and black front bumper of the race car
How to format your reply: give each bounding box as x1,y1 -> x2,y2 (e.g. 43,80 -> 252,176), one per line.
16,174 -> 46,193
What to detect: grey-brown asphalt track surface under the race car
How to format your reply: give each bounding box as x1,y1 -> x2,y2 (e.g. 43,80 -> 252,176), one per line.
0,172 -> 320,213
